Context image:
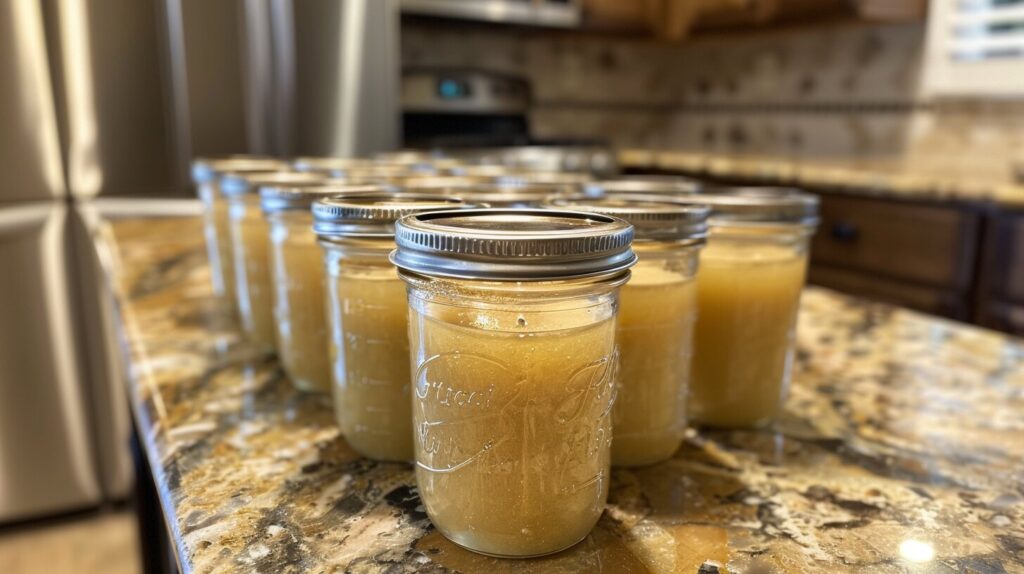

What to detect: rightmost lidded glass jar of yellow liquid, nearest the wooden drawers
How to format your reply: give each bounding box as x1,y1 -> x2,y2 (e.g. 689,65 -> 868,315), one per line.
675,188 -> 818,427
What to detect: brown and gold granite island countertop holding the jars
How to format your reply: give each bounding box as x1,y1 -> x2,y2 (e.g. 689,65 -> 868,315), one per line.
97,213 -> 1024,574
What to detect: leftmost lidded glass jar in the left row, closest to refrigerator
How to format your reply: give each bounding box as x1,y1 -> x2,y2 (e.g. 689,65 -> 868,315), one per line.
191,156 -> 285,312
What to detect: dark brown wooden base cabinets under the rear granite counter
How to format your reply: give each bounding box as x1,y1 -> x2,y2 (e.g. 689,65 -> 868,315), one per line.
618,161 -> 1024,335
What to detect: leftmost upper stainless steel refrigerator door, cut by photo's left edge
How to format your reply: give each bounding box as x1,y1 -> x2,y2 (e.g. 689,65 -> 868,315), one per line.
0,0 -> 65,202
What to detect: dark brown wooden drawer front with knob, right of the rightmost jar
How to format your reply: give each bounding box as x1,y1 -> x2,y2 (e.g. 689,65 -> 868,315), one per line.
811,194 -> 979,290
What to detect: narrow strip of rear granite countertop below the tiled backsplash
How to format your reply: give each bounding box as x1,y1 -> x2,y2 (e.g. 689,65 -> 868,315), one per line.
618,149 -> 1024,208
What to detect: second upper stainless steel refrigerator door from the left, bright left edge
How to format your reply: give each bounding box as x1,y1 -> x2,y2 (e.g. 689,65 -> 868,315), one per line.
47,0 -> 188,197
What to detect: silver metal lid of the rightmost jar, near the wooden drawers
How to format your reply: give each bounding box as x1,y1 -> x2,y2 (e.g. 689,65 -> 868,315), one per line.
674,187 -> 818,227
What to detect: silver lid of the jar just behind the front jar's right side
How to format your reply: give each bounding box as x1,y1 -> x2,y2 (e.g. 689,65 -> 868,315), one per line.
545,193 -> 711,244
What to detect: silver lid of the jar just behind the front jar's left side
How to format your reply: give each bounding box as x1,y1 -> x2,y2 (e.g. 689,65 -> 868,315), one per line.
312,192 -> 466,237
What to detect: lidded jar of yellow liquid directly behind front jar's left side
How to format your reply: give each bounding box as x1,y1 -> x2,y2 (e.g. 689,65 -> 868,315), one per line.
312,192 -> 471,460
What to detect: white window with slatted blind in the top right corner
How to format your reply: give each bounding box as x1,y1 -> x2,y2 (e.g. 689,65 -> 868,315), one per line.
925,0 -> 1024,97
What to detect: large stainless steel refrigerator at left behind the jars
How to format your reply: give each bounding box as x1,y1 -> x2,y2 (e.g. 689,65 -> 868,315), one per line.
0,0 -> 398,524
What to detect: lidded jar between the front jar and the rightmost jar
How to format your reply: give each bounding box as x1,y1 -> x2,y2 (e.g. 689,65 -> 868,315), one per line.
550,193 -> 708,467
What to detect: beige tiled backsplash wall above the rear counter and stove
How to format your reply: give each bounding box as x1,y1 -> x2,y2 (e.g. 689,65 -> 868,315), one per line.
401,20 -> 1024,177
